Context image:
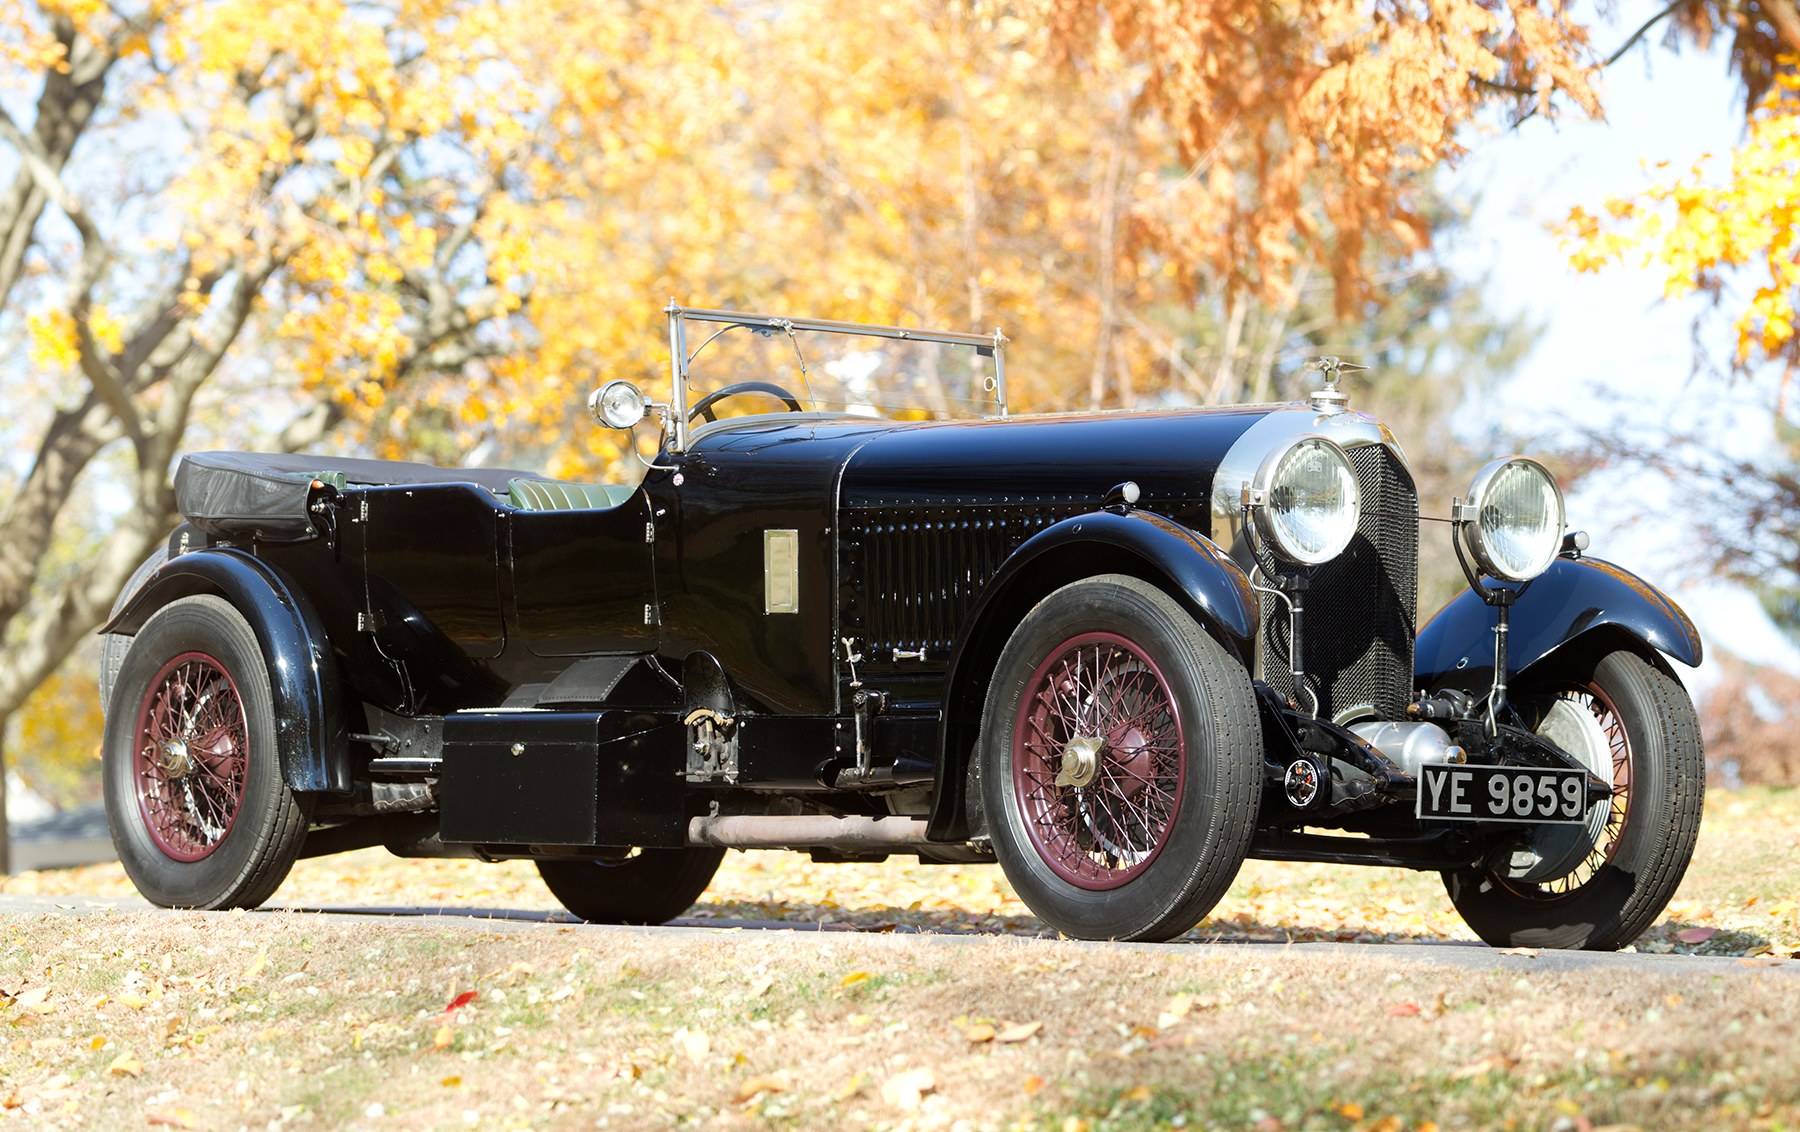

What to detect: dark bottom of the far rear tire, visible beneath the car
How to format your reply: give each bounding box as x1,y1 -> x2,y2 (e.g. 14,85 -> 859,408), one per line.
538,848 -> 725,923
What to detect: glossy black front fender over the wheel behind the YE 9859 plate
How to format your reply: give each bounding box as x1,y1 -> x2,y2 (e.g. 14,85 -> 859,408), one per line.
1415,558 -> 1703,693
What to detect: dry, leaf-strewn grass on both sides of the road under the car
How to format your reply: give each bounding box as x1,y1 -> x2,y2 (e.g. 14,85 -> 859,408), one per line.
0,790 -> 1800,1132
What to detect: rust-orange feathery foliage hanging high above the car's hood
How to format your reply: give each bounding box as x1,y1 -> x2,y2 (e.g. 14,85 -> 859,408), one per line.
1046,0 -> 1598,317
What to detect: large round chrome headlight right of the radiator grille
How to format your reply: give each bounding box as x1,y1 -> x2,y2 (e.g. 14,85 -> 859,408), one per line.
1458,455 -> 1564,581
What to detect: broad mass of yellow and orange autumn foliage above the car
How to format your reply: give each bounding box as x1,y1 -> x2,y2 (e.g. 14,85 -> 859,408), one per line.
0,0 -> 1591,472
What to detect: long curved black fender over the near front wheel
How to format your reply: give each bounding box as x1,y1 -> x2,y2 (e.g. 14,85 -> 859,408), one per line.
927,511 -> 1256,840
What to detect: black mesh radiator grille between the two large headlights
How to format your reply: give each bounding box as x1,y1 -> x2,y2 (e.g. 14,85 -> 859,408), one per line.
1262,445 -> 1418,720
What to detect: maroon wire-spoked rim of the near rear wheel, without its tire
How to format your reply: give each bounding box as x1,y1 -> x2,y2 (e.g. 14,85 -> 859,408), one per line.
131,653 -> 250,860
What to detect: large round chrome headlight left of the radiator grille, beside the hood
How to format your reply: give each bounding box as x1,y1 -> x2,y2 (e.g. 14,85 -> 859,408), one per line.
1251,436 -> 1363,565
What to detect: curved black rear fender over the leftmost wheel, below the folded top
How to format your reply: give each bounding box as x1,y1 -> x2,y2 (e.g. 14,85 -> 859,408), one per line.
101,547 -> 351,794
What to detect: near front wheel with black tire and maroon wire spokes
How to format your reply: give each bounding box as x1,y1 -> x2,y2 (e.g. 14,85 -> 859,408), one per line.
979,574 -> 1262,939
